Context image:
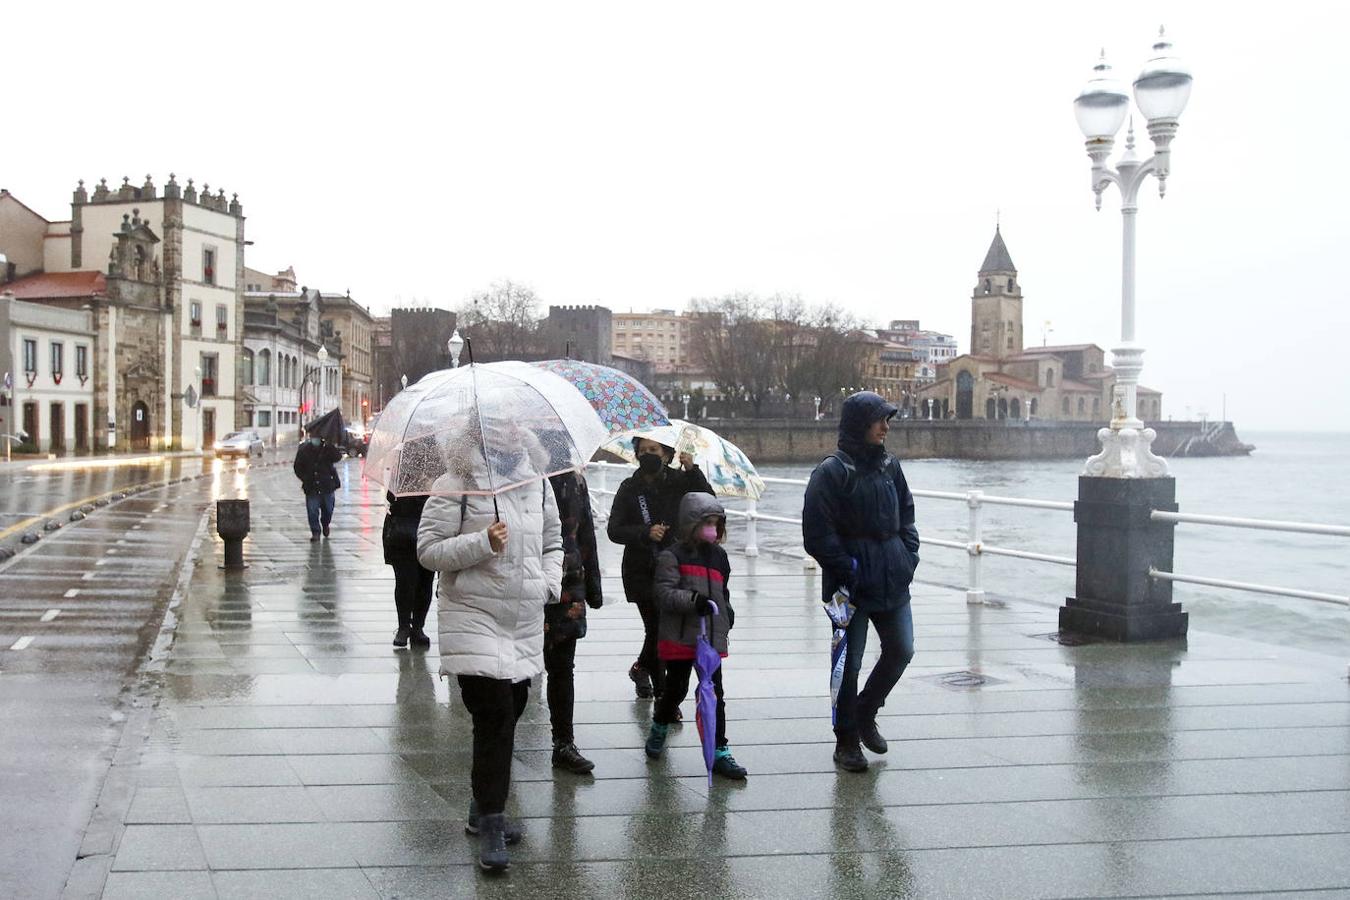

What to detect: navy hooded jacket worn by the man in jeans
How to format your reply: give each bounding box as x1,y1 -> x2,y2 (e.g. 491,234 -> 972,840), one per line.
802,391 -> 919,613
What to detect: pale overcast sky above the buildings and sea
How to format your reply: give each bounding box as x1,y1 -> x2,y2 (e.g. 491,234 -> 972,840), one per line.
0,0 -> 1350,430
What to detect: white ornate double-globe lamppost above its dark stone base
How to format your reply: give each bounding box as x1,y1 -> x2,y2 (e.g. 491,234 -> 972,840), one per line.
1073,28 -> 1192,478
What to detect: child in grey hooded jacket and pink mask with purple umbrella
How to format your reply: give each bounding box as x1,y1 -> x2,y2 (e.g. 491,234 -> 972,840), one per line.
645,493 -> 747,781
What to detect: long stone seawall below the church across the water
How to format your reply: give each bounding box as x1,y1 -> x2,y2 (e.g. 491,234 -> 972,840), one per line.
698,418 -> 1253,463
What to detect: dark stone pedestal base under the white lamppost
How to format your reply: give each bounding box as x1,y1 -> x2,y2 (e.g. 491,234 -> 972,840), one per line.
1060,475 -> 1188,641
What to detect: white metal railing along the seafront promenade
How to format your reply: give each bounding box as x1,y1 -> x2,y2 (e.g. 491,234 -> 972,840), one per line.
589,463 -> 1350,607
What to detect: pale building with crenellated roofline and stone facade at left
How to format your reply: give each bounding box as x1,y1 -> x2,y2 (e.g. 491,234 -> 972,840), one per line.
0,174 -> 244,449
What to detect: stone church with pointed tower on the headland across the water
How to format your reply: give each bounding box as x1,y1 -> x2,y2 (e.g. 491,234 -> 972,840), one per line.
918,228 -> 1162,422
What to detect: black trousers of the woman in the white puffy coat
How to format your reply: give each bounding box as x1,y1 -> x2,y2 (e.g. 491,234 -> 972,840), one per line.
459,675 -> 529,815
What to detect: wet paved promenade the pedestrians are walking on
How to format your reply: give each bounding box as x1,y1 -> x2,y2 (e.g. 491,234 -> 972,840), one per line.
69,464 -> 1350,899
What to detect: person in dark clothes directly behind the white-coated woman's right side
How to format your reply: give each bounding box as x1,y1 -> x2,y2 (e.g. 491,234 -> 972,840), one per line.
544,471 -> 605,775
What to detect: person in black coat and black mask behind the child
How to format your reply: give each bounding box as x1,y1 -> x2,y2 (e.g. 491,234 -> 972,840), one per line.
608,437 -> 713,699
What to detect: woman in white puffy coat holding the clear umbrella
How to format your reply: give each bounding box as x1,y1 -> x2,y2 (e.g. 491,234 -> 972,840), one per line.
417,451 -> 563,872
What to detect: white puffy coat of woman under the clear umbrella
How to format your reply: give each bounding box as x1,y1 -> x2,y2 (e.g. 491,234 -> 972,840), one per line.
417,479 -> 563,681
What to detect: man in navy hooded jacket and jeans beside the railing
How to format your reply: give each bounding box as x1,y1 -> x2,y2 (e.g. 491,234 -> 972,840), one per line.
802,391 -> 919,772
